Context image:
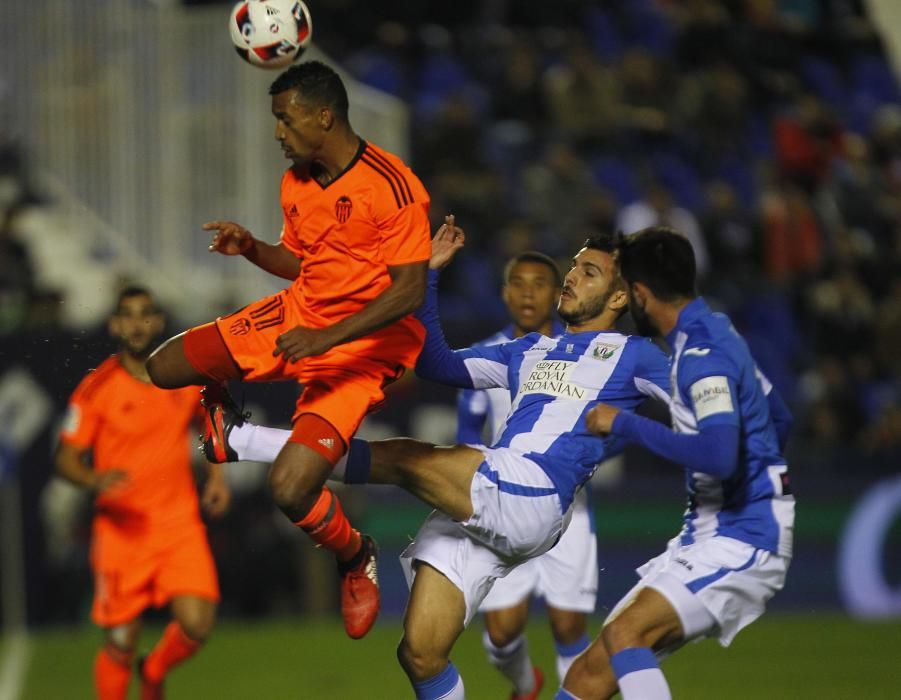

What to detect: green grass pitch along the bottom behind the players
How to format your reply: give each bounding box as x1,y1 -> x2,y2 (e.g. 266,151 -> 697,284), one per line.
14,614 -> 901,700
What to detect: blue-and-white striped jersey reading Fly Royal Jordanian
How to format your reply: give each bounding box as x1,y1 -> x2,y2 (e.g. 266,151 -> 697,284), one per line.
416,288 -> 669,511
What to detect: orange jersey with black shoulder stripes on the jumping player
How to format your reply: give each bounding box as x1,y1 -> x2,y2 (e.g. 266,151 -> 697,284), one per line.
281,141 -> 431,366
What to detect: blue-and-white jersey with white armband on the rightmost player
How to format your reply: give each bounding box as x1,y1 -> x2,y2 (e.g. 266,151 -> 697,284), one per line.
667,298 -> 795,556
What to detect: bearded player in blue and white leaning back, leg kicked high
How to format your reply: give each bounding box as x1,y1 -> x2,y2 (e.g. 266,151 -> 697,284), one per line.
200,217 -> 669,700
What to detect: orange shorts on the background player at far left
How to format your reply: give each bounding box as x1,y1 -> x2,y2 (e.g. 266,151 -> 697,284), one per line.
91,522 -> 219,627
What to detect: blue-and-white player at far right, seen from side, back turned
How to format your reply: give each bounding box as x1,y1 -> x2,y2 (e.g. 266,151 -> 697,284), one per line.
557,227 -> 795,700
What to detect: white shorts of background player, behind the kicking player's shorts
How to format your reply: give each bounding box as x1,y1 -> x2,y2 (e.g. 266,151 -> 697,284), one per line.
479,489 -> 598,613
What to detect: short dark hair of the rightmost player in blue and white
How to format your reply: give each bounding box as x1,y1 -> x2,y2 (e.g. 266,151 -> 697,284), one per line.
619,226 -> 697,302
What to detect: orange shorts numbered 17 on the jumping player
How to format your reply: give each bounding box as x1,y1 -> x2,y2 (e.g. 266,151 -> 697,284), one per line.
191,290 -> 422,444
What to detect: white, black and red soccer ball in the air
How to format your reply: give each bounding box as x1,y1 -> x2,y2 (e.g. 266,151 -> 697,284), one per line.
228,0 -> 313,69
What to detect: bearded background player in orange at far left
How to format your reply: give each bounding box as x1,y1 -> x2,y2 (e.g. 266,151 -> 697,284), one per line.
56,287 -> 230,700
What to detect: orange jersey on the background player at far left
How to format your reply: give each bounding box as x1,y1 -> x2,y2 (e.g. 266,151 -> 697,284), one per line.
60,355 -> 200,535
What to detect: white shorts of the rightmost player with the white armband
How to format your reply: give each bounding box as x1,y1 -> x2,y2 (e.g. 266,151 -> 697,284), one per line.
607,537 -> 791,644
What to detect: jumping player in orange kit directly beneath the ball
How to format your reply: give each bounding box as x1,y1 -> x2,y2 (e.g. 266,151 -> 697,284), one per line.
148,61 -> 431,638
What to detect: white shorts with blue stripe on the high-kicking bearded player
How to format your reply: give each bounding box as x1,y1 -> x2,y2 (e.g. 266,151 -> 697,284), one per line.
400,447 -> 569,624
